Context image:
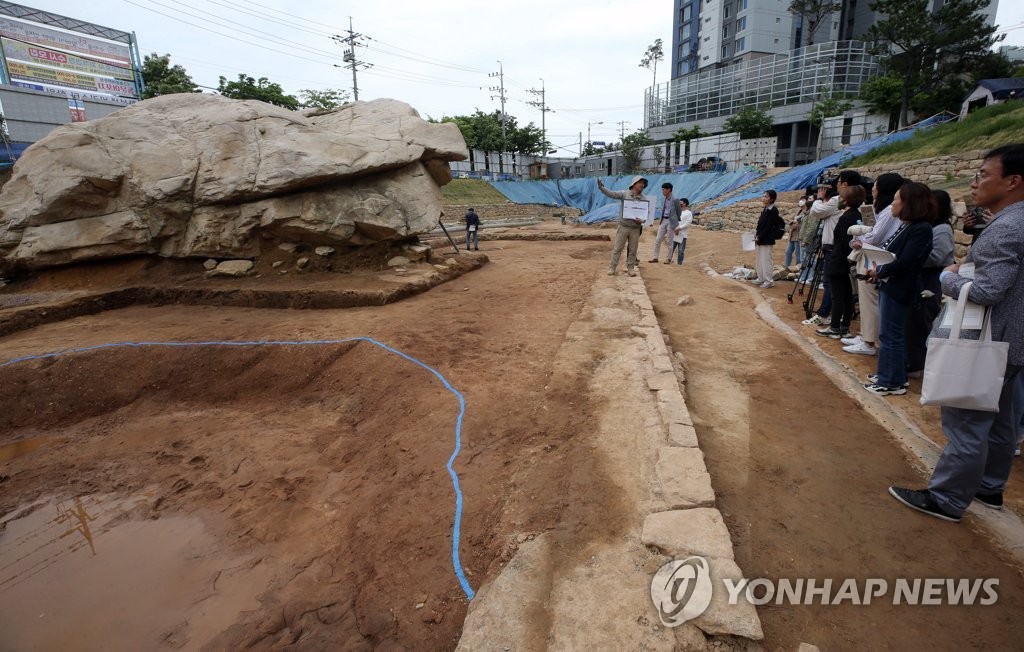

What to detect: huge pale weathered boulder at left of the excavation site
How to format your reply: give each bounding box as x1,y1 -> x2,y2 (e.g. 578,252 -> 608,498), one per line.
0,94 -> 468,269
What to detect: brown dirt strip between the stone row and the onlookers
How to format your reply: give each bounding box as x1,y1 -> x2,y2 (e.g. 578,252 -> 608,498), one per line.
641,230 -> 1024,650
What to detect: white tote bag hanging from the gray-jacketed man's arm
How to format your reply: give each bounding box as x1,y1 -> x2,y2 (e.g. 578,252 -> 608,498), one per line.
921,284 -> 1010,412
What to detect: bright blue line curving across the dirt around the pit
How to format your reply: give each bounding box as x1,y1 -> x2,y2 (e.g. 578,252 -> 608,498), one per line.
0,337 -> 476,600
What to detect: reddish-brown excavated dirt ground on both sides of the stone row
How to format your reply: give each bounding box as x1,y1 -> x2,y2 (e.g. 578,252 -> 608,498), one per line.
0,223 -> 1024,650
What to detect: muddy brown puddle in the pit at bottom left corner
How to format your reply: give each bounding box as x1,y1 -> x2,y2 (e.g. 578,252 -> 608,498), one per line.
0,487 -> 270,650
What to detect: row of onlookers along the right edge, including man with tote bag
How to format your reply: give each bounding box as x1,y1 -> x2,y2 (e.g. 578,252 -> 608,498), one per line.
758,144 -> 1024,522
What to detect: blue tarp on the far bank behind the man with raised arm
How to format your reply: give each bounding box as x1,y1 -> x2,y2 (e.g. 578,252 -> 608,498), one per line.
490,170 -> 764,223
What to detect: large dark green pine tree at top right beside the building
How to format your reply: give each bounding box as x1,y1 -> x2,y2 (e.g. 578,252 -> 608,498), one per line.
867,0 -> 1001,127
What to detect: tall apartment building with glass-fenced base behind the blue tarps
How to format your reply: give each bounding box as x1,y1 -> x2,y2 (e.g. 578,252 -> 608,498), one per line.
644,0 -> 998,165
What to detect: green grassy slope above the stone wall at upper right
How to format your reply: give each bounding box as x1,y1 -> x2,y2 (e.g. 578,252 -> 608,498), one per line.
845,101 -> 1024,168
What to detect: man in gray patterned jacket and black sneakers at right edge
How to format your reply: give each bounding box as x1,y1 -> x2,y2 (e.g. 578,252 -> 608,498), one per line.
889,143 -> 1024,522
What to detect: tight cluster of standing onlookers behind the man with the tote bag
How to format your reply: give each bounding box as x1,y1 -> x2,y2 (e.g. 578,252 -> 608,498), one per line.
786,170 -> 953,396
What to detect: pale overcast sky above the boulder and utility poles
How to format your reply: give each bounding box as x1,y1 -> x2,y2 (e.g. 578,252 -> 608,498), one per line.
19,0 -> 1024,156
